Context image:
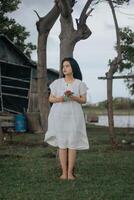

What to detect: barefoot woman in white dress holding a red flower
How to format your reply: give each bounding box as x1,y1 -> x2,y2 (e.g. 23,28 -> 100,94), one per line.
44,58 -> 89,180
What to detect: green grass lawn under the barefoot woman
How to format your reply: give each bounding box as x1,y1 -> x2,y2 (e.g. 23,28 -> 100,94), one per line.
0,125 -> 134,200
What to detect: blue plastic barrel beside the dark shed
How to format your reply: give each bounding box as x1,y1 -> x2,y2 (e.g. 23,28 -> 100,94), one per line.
15,114 -> 27,133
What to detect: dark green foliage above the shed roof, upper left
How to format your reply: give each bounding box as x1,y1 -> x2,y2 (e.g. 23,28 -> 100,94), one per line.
0,0 -> 36,57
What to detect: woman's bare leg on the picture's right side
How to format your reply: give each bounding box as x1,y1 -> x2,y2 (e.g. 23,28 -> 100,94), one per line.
68,149 -> 76,179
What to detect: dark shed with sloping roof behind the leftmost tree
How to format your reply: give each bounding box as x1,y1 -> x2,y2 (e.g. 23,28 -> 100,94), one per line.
0,35 -> 59,113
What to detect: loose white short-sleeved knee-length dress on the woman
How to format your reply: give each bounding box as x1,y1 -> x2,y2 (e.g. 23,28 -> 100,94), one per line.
44,78 -> 89,150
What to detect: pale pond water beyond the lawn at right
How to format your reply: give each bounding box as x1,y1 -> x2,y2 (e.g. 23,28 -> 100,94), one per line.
92,115 -> 134,127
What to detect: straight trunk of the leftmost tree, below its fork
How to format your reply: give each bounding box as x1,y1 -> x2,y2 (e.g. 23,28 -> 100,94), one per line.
37,34 -> 49,132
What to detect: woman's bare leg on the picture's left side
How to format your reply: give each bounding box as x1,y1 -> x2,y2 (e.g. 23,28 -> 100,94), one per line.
59,148 -> 67,179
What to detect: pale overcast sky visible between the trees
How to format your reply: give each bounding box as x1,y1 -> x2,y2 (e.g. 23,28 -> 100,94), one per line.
8,0 -> 134,103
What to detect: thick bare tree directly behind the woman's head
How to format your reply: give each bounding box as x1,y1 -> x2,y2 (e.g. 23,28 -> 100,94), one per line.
59,0 -> 93,76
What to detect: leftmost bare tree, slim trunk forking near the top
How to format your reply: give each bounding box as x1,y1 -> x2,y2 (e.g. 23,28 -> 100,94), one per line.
35,0 -> 60,132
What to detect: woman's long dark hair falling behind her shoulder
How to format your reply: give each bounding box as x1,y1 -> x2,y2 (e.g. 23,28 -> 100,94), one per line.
61,57 -> 82,81
